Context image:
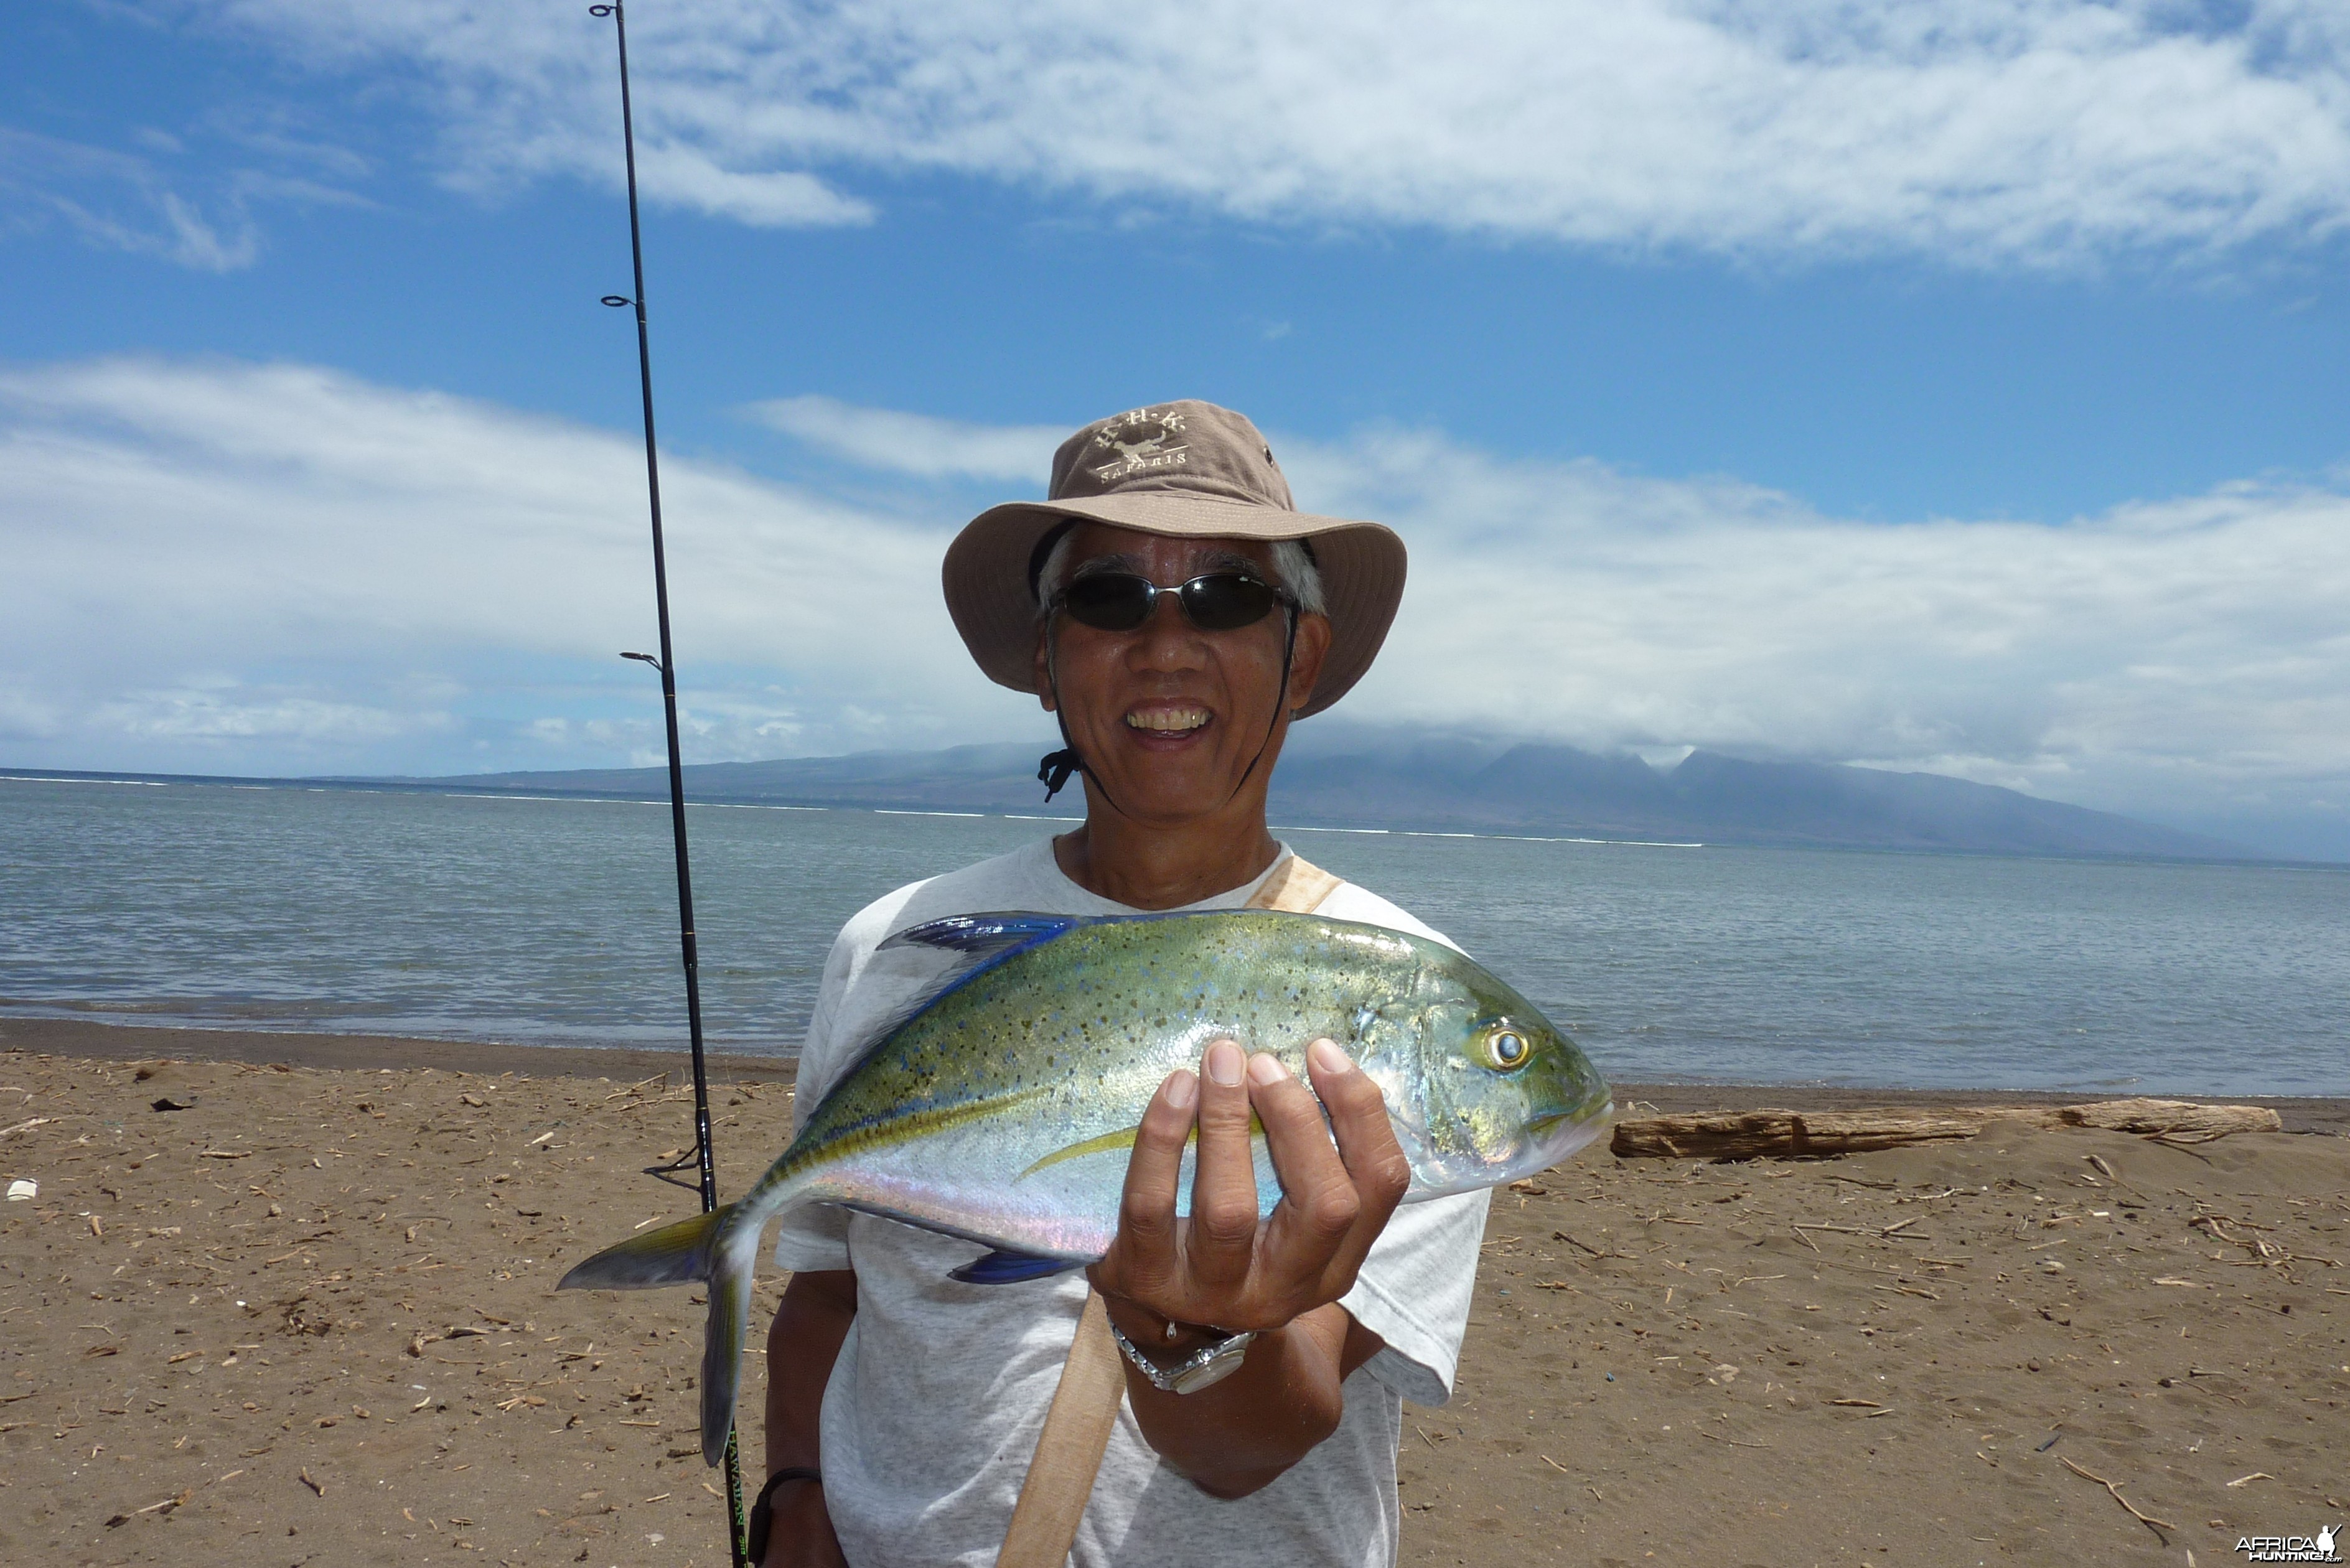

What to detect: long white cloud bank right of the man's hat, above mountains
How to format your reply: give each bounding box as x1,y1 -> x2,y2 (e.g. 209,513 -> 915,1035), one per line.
1283,430 -> 2350,846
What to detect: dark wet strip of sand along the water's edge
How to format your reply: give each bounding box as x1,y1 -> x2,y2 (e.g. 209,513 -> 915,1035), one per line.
0,1013 -> 2350,1138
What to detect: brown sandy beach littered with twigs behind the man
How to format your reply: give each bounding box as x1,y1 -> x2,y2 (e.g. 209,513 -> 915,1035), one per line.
0,1020 -> 2350,1566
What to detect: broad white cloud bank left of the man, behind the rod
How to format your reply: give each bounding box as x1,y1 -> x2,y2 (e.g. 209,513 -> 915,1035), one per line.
0,360 -> 1029,771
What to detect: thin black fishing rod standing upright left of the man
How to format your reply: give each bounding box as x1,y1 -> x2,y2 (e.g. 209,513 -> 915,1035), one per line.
588,0 -> 750,1568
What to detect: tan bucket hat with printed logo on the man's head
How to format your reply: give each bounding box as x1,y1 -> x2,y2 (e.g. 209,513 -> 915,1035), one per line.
942,398 -> 1405,717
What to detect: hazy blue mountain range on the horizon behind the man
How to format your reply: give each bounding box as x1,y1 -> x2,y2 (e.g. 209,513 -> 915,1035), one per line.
402,726 -> 2259,861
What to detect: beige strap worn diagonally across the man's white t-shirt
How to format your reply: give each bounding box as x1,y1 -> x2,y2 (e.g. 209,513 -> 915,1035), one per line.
996,856 -> 1339,1568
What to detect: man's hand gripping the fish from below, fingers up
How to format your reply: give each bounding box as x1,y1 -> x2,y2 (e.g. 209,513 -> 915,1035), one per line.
1090,1039 -> 1410,1350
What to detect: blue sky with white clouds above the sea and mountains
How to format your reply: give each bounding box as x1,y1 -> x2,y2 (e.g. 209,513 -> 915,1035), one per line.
0,0 -> 2350,858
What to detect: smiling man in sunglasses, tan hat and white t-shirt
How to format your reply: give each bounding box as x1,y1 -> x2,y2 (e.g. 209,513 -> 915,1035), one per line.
766,402 -> 1485,1568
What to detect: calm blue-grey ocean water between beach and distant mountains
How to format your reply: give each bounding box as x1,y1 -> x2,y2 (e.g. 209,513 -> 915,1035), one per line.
0,778 -> 2350,1096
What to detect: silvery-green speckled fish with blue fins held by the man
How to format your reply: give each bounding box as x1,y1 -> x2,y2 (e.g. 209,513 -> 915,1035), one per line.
557,912 -> 1614,1465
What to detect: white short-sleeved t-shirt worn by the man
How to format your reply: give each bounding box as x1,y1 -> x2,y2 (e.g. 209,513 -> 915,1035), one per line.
775,839 -> 1487,1568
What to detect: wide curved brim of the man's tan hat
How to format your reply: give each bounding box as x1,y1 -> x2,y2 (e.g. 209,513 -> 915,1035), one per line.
942,492 -> 1408,717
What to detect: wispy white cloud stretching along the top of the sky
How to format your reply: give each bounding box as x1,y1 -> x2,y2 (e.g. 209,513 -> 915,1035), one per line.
195,0 -> 2350,266
